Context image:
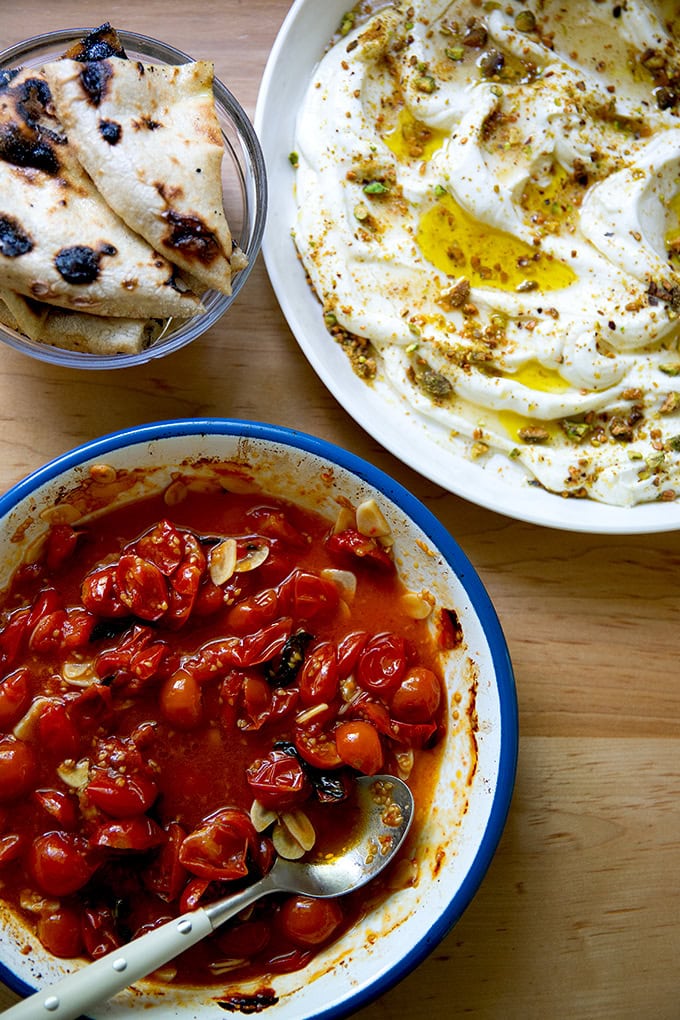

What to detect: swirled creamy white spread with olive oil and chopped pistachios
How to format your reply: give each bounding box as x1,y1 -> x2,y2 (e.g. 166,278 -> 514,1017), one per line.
295,0 -> 680,506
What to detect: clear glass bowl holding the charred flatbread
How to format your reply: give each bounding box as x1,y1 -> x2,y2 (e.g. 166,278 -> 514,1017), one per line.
0,29 -> 267,368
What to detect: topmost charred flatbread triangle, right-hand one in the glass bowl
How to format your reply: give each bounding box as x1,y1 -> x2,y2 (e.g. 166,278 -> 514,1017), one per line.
43,56 -> 246,294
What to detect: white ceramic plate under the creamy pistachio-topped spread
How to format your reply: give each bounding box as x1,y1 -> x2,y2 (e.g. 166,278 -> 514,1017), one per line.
255,0 -> 680,534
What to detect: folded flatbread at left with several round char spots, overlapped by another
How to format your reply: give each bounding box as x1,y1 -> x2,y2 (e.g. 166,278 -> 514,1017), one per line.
0,68 -> 203,318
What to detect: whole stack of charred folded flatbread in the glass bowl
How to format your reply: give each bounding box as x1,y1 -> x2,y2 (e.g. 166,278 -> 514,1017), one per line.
0,24 -> 246,354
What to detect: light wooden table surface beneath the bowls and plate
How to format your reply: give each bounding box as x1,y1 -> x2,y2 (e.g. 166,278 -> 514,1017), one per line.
0,0 -> 680,1020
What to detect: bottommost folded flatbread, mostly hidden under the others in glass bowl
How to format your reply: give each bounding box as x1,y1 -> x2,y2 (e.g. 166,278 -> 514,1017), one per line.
0,289 -> 162,355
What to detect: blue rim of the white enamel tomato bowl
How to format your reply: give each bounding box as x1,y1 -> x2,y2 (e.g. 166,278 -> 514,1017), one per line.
0,418 -> 519,1020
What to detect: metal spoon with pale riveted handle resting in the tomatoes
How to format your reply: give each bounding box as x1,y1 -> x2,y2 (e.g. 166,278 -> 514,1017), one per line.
2,775 -> 413,1020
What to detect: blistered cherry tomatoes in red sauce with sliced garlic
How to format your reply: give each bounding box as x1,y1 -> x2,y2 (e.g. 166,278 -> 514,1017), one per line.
0,492 -> 444,984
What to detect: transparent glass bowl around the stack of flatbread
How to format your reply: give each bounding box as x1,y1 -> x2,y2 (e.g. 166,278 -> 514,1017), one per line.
0,28 -> 268,369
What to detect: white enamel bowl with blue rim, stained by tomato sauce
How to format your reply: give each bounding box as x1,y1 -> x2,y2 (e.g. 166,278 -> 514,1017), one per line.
0,419 -> 518,1020
